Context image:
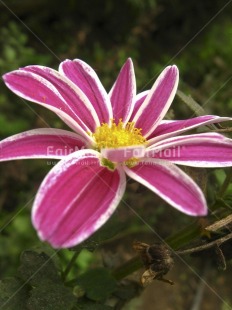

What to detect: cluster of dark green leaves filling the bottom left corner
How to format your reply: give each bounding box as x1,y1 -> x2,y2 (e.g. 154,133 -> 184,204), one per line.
0,250 -> 76,310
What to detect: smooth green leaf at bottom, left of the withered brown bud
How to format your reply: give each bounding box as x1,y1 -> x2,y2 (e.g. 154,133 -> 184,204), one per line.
77,268 -> 117,302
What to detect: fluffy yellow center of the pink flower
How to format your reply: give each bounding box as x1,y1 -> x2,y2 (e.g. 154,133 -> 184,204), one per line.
91,119 -> 146,151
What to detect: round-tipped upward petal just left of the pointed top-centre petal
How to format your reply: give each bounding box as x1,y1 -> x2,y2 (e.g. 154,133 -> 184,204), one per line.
59,59 -> 113,124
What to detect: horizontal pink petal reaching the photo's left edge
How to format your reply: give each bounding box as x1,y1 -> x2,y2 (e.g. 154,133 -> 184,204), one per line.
0,128 -> 86,161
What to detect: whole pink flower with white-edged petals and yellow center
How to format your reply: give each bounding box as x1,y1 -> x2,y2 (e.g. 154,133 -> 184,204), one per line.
0,59 -> 232,248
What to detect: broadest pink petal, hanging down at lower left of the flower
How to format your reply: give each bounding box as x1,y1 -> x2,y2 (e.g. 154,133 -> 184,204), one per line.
32,150 -> 126,248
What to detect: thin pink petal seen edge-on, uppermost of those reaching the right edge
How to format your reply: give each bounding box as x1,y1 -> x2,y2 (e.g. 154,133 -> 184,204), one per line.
148,115 -> 231,145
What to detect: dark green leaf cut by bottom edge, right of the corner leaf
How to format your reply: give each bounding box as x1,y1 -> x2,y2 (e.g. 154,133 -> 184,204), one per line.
26,281 -> 76,310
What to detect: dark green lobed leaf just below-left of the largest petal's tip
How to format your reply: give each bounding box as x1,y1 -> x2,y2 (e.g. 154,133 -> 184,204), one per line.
18,250 -> 61,286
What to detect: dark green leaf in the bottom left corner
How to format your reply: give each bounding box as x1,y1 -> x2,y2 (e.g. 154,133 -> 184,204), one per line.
0,278 -> 29,310
